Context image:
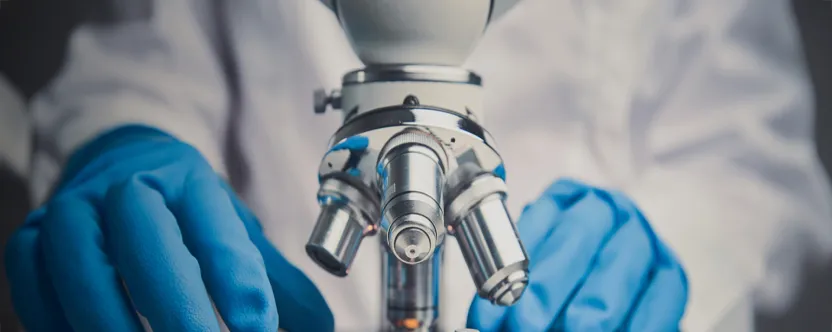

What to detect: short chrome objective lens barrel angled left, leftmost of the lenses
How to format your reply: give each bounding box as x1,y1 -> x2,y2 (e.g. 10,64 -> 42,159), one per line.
306,177 -> 379,277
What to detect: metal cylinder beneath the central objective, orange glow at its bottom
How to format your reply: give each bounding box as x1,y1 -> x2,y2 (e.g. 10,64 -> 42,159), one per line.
382,245 -> 443,332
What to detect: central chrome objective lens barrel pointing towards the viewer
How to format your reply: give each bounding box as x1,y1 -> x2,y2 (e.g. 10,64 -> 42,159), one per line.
378,129 -> 447,264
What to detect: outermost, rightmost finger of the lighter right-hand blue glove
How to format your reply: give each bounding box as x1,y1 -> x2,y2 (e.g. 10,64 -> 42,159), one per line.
627,244 -> 688,332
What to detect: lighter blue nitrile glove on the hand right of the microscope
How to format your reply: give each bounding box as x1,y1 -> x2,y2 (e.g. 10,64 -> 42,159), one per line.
468,180 -> 688,332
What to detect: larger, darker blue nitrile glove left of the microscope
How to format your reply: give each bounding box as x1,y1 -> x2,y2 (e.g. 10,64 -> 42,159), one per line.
6,126 -> 334,332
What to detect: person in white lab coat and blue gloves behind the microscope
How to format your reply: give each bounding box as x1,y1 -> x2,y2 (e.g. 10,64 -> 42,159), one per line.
6,0 -> 832,331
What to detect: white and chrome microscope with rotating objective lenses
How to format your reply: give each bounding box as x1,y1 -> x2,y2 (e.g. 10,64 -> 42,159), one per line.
306,0 -> 528,331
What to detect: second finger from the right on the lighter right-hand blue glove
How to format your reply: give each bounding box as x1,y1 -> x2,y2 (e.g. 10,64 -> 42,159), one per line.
563,211 -> 655,331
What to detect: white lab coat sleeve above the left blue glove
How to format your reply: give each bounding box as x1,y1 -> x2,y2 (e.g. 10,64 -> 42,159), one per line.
31,0 -> 229,202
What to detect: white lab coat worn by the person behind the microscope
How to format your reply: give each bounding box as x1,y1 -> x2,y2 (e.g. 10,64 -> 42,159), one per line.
26,0 -> 832,331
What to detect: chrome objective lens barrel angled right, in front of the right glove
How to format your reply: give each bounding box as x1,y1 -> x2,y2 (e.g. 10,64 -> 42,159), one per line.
446,165 -> 529,306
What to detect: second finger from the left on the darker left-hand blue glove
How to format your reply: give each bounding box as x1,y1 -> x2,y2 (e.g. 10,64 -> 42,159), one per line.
42,196 -> 142,331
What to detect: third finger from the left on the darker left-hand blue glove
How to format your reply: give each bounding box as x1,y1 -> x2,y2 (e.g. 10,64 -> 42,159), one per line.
104,175 -> 219,332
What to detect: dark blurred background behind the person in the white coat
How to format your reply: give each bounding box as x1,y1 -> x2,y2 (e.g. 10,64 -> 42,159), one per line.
0,0 -> 832,332
